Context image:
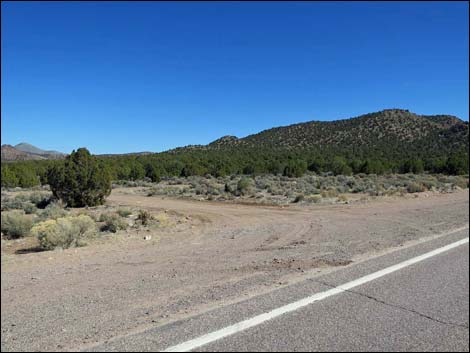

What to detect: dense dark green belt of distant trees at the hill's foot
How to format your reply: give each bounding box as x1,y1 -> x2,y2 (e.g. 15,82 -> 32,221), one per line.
2,148 -> 469,187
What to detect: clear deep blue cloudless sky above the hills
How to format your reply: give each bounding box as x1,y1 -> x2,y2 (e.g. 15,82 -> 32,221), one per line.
1,1 -> 469,153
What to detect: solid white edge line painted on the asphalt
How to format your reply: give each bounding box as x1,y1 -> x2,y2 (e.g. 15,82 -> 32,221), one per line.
163,238 -> 468,352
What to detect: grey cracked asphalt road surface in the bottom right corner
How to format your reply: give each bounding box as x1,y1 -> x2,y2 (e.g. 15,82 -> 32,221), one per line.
88,229 -> 469,351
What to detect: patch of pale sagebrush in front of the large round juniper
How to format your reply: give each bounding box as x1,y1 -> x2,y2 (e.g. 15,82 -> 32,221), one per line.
1,189 -> 162,250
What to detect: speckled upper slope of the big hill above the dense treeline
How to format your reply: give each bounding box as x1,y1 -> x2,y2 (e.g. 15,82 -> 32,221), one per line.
202,109 -> 468,156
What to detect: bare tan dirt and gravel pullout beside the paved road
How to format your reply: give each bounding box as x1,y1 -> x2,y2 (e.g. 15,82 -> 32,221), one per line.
1,189 -> 469,351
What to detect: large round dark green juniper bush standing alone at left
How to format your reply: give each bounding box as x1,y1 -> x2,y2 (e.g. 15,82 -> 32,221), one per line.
48,148 -> 112,207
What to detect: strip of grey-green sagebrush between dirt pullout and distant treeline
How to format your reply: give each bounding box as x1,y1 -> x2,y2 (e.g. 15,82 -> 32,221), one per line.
145,173 -> 468,204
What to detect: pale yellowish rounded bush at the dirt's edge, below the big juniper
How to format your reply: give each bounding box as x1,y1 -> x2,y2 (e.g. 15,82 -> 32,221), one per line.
31,215 -> 96,250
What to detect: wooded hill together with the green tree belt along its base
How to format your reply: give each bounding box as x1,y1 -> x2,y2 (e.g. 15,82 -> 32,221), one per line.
2,109 -> 469,186
